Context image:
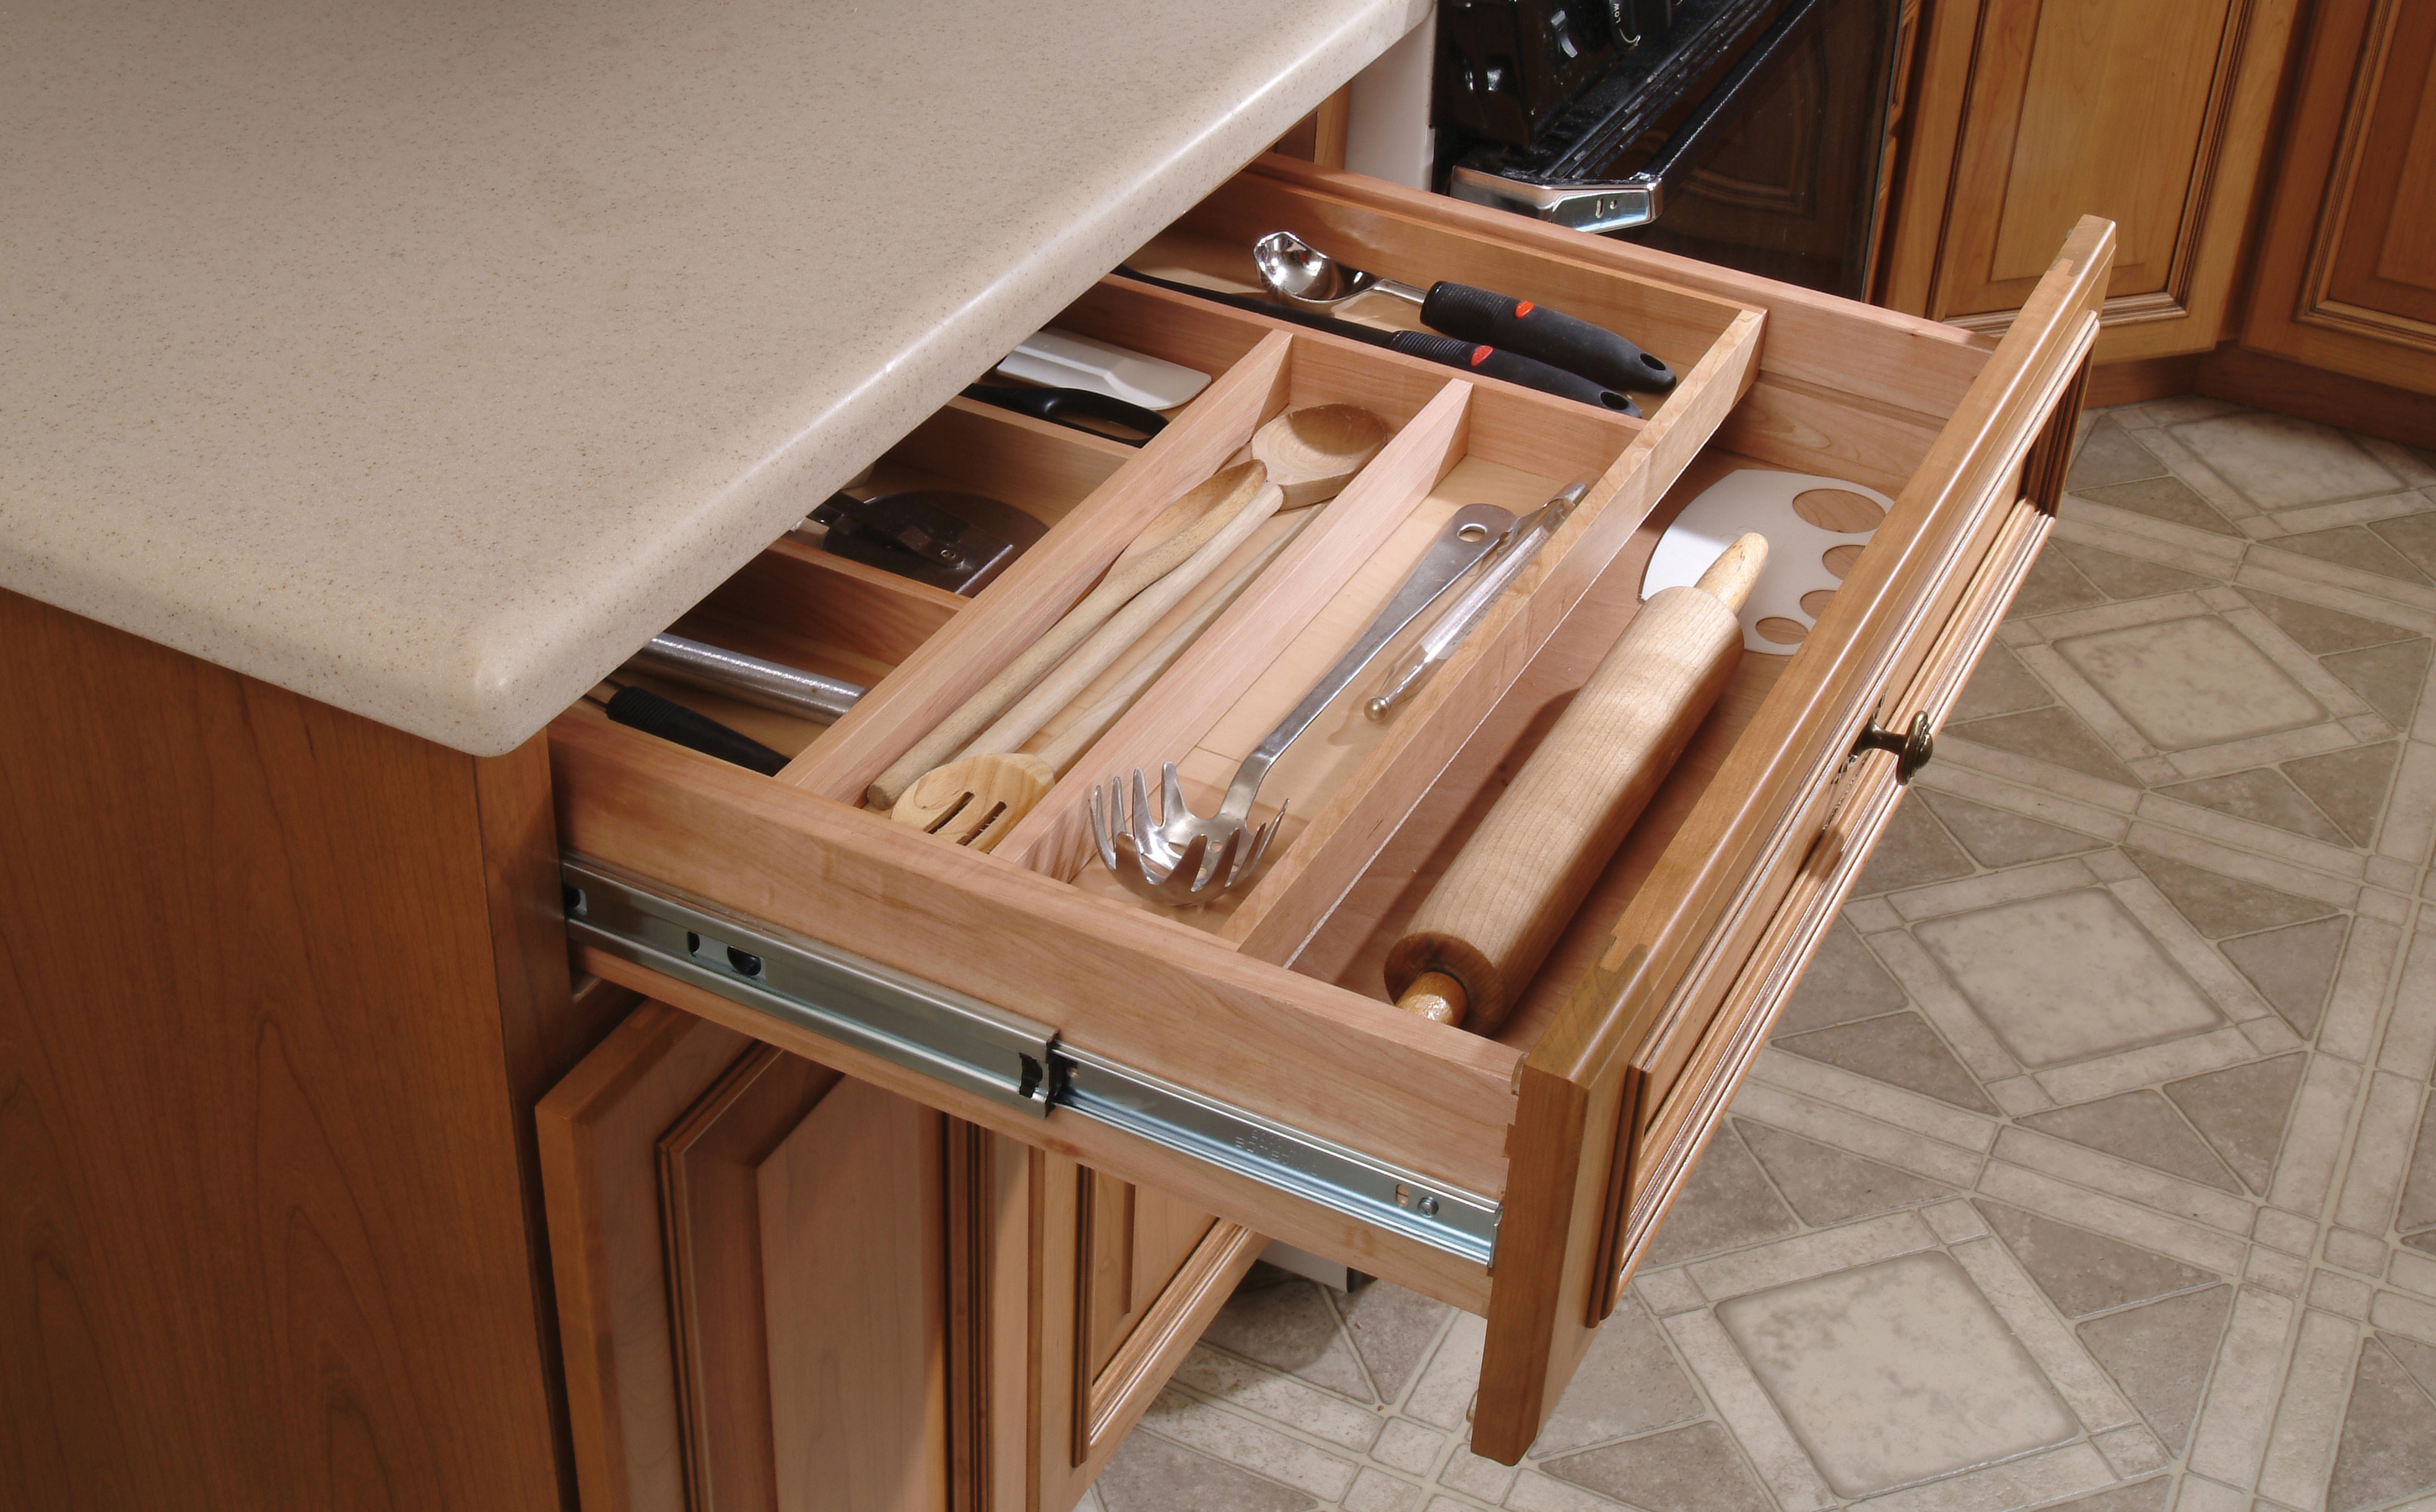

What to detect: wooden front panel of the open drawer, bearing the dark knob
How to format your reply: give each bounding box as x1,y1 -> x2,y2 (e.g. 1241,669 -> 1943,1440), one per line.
1474,219 -> 2112,1463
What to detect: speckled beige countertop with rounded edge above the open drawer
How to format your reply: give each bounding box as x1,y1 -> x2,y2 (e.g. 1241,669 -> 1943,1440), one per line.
0,0 -> 1427,755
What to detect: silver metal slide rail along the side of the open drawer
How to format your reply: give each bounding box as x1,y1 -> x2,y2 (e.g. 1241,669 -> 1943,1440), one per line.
560,857 -> 1498,1266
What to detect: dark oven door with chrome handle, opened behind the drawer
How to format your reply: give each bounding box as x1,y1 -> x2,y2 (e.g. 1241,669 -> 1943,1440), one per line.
1447,0 -> 1900,300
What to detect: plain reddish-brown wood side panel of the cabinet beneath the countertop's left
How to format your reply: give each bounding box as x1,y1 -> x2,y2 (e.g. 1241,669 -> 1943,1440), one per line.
0,584 -> 607,1510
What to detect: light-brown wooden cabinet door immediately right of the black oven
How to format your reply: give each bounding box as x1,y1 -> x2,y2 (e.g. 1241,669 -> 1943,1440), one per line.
1881,0 -> 2295,360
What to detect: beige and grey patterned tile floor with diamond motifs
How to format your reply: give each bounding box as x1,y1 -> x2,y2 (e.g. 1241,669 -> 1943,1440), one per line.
1084,399 -> 2436,1512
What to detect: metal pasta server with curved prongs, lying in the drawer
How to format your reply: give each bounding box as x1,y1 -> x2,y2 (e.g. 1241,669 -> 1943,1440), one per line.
1091,504 -> 1515,908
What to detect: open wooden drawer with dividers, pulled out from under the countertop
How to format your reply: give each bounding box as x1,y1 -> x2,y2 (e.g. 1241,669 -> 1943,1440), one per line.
550,159 -> 2112,1461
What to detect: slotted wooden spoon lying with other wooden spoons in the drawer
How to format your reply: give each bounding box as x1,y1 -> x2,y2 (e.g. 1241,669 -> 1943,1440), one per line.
889,509 -> 1320,849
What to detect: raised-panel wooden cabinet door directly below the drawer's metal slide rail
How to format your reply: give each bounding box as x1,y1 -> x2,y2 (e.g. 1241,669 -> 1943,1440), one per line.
538,1003 -> 977,1512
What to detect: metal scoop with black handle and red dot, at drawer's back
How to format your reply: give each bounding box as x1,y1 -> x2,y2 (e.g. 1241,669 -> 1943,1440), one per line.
1252,232 -> 1674,394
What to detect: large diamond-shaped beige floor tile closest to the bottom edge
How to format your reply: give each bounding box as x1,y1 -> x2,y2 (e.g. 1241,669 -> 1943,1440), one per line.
1717,1251 -> 2081,1495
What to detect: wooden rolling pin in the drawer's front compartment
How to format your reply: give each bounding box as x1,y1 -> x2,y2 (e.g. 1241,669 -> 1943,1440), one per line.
1386,536 -> 1768,1035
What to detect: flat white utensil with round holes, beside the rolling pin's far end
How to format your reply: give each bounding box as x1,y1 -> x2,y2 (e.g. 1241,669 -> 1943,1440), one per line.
1642,467 -> 1895,658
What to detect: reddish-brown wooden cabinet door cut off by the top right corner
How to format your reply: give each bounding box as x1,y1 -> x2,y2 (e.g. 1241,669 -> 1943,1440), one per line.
2241,0 -> 2436,394
